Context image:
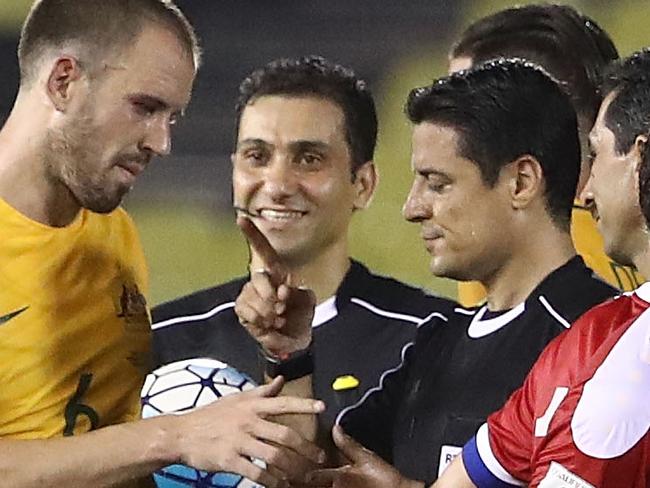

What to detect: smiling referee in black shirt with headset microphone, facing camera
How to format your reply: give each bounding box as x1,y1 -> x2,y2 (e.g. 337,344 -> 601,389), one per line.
148,57 -> 451,431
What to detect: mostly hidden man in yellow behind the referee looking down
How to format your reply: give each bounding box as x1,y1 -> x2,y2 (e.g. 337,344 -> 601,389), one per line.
449,5 -> 643,305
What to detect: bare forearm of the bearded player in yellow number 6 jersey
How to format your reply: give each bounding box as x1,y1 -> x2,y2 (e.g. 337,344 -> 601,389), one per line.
0,417 -> 177,488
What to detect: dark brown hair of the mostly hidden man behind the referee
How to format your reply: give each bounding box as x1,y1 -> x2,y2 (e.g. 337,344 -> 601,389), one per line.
451,4 -> 618,126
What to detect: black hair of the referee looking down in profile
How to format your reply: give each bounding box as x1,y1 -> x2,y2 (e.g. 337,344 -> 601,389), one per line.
406,59 -> 580,229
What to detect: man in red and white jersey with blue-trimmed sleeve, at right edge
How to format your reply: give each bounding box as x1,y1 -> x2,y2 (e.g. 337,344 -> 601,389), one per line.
434,50 -> 650,488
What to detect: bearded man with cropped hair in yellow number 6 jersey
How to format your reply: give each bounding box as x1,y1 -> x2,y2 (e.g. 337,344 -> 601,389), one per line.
0,0 -> 323,487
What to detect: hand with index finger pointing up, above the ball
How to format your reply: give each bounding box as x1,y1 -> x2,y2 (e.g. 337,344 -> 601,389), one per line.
235,216 -> 316,356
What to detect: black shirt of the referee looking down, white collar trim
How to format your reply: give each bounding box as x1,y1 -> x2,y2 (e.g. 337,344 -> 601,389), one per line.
340,257 -> 617,486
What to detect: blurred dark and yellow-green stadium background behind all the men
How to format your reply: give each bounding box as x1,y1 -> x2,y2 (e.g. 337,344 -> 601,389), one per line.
0,0 -> 650,304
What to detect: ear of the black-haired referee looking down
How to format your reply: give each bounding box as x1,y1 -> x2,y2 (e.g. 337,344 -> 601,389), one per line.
501,154 -> 545,209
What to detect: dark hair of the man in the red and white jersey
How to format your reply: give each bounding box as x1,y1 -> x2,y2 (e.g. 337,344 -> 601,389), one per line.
601,49 -> 650,226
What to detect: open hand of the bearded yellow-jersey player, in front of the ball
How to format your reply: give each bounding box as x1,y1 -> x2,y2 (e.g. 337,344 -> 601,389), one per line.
169,377 -> 325,488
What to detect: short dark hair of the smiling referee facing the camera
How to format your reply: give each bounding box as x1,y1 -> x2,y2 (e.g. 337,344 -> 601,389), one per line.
235,56 -> 377,171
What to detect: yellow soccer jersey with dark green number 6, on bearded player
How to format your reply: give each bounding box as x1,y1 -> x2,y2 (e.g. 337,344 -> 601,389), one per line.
0,200 -> 150,439
